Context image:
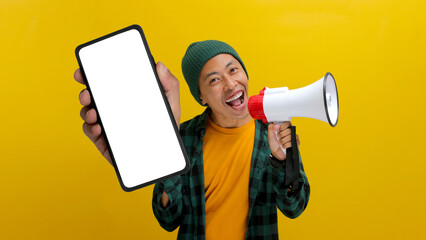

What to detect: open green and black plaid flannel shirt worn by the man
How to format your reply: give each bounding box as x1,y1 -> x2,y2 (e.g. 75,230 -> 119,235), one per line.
152,108 -> 310,240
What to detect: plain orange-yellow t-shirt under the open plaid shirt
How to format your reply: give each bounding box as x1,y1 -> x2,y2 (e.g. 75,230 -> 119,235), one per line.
203,119 -> 255,240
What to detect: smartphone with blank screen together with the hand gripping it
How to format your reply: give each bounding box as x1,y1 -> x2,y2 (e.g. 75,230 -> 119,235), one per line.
76,25 -> 189,191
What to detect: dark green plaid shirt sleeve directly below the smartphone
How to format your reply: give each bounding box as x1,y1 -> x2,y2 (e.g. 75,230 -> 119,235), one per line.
152,176 -> 183,232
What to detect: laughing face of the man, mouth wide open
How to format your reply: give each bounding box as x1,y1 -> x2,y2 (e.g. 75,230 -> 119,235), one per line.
199,54 -> 251,127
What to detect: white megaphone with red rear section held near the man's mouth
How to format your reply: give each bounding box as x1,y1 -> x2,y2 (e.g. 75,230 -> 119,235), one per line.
248,73 -> 339,127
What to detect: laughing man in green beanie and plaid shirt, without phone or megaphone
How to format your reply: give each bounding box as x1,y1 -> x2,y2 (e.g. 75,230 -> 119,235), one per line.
75,40 -> 310,240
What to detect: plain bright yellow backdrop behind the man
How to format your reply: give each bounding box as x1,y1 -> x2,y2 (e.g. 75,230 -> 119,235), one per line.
0,0 -> 426,239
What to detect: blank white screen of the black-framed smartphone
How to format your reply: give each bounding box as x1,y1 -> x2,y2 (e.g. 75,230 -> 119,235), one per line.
79,29 -> 186,188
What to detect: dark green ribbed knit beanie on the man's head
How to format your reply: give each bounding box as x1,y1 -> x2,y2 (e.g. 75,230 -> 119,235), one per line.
182,40 -> 248,105
